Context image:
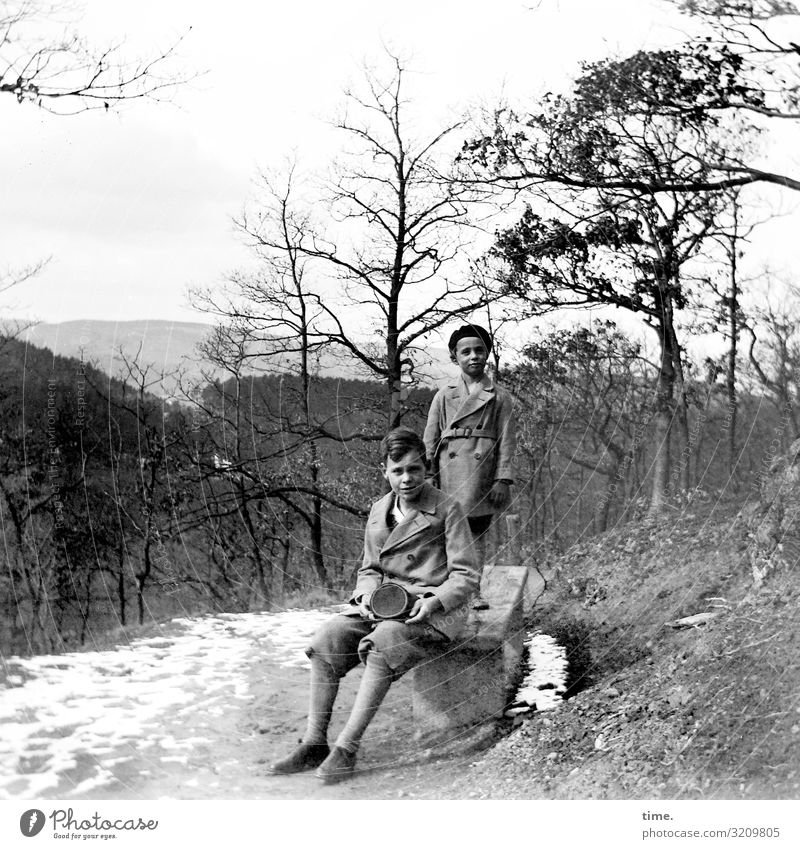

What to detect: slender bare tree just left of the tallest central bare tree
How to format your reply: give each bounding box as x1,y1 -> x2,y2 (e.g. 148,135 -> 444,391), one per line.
193,167 -> 377,586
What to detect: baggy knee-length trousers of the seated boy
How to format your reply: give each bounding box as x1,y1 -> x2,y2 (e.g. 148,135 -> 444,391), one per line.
306,614 -> 450,680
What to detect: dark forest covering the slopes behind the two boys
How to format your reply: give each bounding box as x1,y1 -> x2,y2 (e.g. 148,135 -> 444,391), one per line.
0,298 -> 800,653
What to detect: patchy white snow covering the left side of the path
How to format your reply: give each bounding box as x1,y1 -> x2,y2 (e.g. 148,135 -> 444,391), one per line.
0,608 -> 338,799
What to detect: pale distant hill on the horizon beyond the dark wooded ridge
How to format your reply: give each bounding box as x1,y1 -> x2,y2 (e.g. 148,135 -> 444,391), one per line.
24,319 -> 453,393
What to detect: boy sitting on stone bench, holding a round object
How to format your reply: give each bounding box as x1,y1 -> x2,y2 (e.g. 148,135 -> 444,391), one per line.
271,428 -> 479,784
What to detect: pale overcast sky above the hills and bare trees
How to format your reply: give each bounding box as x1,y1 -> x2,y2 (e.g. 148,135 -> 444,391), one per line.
0,0 -> 797,332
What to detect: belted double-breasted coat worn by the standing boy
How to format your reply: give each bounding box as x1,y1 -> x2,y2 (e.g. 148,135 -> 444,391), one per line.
424,375 -> 516,518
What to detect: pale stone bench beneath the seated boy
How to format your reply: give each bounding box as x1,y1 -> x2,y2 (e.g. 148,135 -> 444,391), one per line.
413,566 -> 528,738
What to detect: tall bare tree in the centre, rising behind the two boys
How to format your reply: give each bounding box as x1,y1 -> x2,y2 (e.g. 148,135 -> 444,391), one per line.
231,56 -> 496,427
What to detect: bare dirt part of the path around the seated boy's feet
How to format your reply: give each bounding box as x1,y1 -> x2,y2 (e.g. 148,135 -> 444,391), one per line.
64,661 -> 474,799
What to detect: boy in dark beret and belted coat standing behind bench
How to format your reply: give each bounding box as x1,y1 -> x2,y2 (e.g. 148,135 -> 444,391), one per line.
424,324 -> 516,609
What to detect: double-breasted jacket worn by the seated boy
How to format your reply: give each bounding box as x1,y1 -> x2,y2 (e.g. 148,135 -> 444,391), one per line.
346,483 -> 480,639
